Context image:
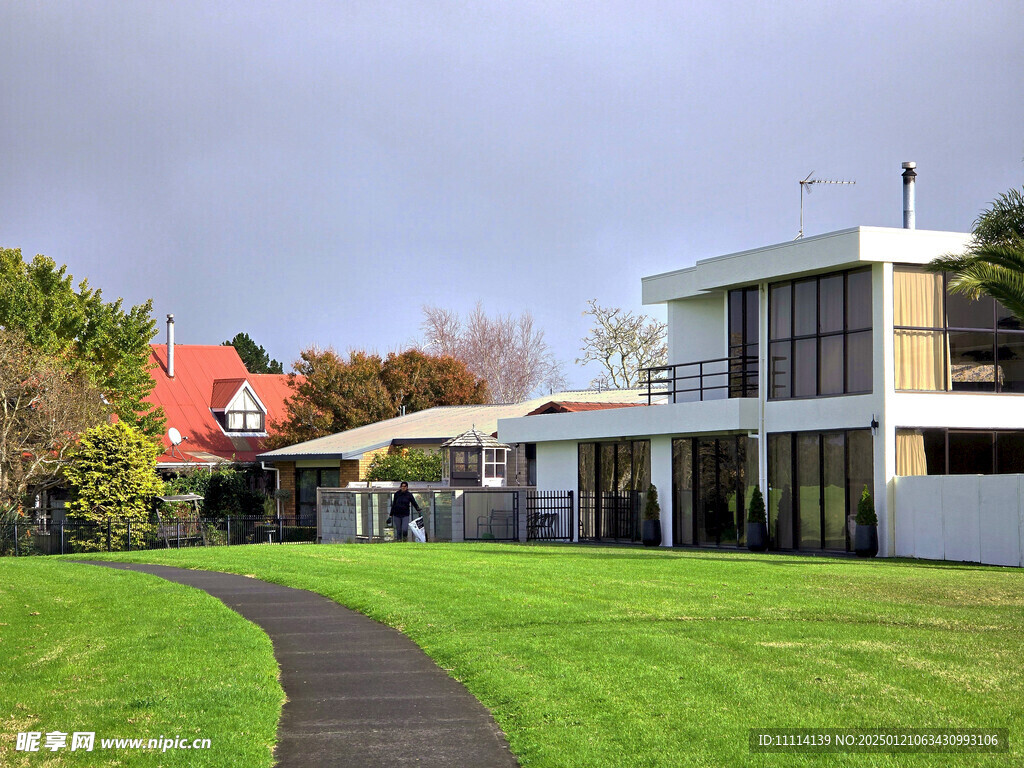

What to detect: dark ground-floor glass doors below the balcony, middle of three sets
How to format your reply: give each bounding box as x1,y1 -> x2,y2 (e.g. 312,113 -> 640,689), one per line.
672,435 -> 758,547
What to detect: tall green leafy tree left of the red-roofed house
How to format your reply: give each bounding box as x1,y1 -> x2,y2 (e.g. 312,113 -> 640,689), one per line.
0,248 -> 164,436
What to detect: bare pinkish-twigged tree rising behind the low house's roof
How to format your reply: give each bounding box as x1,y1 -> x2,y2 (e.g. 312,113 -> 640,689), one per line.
421,303 -> 565,402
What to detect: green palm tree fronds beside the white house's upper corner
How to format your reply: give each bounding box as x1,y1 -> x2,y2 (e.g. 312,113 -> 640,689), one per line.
926,189 -> 1024,322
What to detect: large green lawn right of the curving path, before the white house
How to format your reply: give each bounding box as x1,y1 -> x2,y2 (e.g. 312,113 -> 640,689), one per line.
74,544 -> 1024,766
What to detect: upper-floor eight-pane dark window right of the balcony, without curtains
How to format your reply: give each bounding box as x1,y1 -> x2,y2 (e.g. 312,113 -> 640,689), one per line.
768,268 -> 872,399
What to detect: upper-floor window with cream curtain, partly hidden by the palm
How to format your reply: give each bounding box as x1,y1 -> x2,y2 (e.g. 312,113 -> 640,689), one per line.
893,266 -> 1024,392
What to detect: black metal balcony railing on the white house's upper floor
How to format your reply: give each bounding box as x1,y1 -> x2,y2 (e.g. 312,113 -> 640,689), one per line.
641,355 -> 758,406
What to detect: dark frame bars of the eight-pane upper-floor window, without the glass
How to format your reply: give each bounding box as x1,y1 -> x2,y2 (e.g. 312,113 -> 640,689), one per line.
767,266 -> 874,400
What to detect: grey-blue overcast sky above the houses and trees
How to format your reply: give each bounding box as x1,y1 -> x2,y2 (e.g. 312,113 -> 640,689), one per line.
0,0 -> 1024,387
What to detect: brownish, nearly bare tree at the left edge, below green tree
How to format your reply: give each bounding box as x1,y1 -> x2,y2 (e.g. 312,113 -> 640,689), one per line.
0,328 -> 108,522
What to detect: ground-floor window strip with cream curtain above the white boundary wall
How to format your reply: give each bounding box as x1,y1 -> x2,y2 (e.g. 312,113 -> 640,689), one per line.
896,427 -> 1024,475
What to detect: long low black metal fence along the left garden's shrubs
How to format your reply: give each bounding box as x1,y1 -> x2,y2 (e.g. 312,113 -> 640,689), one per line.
0,516 -> 316,556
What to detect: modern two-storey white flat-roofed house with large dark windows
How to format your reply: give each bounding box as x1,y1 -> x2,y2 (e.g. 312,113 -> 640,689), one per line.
498,204 -> 1024,564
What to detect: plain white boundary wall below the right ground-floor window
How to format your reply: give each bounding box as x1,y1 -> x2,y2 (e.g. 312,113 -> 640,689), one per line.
892,475 -> 1024,566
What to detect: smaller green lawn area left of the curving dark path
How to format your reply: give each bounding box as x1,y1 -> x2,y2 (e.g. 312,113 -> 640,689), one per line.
0,557 -> 284,768
